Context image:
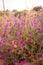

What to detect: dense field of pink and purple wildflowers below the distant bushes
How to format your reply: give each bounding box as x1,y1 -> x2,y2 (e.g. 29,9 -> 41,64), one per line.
0,11 -> 43,65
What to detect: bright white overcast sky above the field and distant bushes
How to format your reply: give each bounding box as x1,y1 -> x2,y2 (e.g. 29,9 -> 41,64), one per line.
0,0 -> 43,11
